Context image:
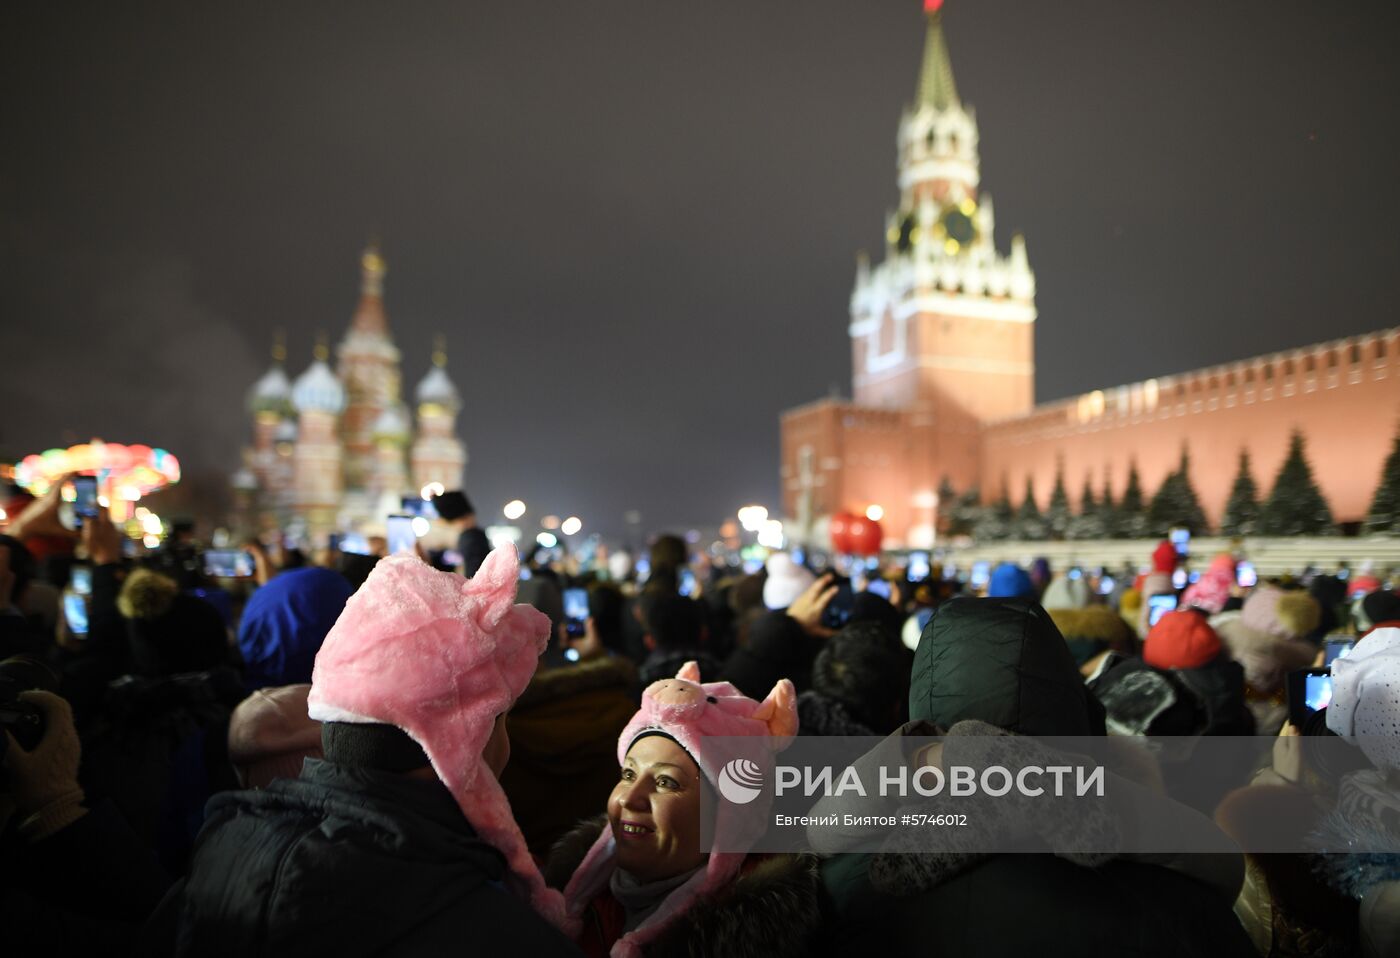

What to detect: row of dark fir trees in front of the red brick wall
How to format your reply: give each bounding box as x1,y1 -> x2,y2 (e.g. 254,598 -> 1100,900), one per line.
939,431 -> 1400,541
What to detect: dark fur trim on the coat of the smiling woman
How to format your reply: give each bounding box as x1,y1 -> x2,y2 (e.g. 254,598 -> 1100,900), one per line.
545,815 -> 827,958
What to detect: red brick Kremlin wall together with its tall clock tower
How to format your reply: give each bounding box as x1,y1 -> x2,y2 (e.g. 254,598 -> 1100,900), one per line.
780,4 -> 1400,548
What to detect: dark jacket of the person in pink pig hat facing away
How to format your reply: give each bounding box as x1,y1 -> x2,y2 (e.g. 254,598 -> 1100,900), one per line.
151,759 -> 578,958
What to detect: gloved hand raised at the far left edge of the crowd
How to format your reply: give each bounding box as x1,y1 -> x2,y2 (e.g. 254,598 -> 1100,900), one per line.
4,690 -> 85,842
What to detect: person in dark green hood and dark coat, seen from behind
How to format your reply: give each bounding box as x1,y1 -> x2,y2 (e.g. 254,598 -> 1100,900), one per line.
808,598 -> 1252,958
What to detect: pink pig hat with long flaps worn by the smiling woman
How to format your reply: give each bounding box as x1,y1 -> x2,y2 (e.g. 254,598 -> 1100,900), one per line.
564,662 -> 797,958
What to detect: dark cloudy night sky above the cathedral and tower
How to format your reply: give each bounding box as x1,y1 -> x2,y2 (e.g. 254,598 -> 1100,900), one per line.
0,0 -> 1400,531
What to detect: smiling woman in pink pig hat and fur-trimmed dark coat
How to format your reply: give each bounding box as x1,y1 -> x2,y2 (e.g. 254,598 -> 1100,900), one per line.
546,662 -> 820,958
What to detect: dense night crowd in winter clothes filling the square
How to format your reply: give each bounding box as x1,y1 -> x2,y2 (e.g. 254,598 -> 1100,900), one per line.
0,483 -> 1400,957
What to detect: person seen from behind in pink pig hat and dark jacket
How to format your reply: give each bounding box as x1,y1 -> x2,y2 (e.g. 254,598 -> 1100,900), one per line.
143,546 -> 577,958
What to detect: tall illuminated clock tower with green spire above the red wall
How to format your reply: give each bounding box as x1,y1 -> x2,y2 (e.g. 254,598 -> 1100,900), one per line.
850,0 -> 1036,429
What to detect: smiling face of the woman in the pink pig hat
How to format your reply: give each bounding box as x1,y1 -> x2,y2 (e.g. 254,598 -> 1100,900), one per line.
608,735 -> 706,882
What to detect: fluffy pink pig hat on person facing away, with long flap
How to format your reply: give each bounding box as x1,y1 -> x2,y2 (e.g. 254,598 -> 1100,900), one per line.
307,546 -> 573,933
